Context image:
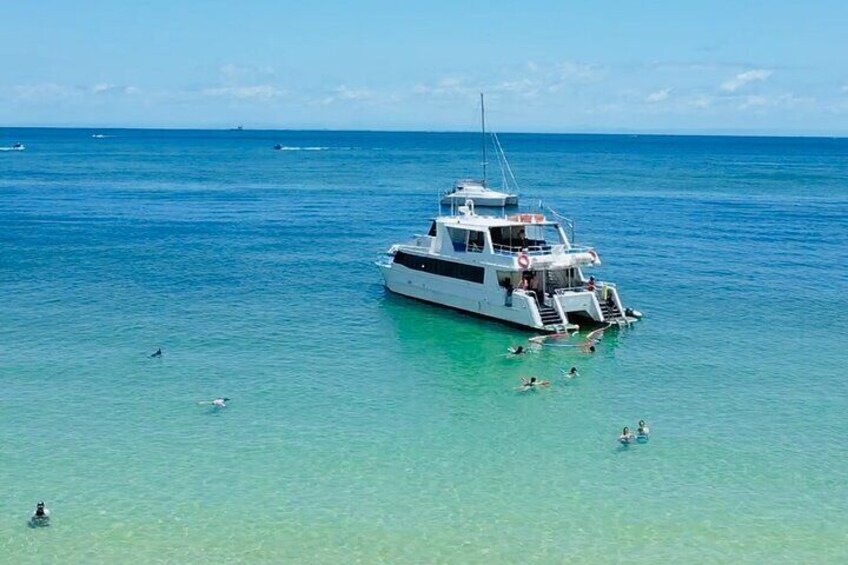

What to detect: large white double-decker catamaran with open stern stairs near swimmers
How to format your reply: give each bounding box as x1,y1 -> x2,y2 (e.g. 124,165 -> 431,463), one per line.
377,201 -> 638,332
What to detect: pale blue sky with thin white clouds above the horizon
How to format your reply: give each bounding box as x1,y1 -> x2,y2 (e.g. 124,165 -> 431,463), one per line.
0,0 -> 848,136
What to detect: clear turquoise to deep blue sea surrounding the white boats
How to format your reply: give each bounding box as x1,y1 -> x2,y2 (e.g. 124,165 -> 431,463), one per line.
0,130 -> 848,563
